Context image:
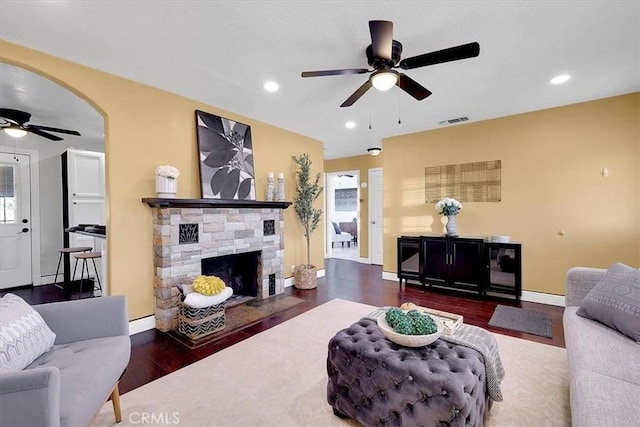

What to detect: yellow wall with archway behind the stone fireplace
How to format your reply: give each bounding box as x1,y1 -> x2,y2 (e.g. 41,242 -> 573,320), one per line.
0,40 -> 324,319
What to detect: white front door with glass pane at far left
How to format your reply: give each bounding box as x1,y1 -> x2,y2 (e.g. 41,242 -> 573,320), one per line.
0,153 -> 32,289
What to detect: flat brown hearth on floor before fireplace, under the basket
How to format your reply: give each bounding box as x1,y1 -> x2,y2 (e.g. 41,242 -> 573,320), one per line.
169,294 -> 306,348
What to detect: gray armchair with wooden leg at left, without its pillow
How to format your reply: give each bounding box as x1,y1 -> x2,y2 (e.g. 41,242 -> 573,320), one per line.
0,296 -> 131,426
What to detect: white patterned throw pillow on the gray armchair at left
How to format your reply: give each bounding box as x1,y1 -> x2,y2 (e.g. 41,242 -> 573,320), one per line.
0,294 -> 56,374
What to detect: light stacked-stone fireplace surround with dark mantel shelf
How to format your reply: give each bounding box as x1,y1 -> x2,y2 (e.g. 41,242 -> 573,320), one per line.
142,198 -> 291,332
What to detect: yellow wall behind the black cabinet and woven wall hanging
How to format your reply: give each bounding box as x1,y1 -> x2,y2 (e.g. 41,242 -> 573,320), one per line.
383,93 -> 640,295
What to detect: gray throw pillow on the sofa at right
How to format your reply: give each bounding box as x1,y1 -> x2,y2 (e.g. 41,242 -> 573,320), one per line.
577,263 -> 640,342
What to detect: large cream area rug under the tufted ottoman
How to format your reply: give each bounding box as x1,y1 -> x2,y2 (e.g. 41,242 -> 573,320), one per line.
92,299 -> 571,427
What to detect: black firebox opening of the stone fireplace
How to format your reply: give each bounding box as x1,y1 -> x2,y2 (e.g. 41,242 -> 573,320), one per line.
201,251 -> 262,299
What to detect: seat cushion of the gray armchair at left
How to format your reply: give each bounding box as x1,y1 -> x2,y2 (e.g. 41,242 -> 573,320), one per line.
26,336 -> 131,426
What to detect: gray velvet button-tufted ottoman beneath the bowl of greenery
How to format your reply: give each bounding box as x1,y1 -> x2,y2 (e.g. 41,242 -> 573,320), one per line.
327,319 -> 489,426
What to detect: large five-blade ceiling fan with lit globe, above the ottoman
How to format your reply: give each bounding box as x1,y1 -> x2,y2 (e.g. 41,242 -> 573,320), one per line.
302,21 -> 480,107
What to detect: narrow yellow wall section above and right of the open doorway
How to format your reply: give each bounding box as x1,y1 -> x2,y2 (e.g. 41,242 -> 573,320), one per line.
324,152 -> 384,258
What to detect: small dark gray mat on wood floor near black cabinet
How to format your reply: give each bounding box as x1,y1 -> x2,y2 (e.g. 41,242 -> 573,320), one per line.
489,305 -> 553,338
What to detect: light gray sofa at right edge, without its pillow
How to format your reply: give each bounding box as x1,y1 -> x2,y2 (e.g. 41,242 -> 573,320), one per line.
563,267 -> 640,427
